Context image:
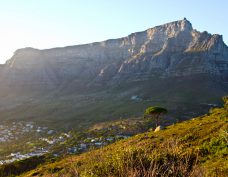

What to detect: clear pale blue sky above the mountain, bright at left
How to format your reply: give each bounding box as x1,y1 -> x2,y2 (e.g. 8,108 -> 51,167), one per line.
0,0 -> 228,63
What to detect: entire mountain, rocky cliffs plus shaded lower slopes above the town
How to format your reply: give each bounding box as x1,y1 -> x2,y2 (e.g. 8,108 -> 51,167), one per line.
0,19 -> 228,127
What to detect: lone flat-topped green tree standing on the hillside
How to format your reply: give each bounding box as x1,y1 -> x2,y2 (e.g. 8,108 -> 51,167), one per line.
144,107 -> 168,127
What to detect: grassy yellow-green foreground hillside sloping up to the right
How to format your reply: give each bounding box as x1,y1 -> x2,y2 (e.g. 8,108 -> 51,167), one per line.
11,99 -> 228,177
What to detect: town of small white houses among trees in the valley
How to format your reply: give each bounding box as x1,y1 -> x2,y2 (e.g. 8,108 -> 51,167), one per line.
0,122 -> 129,165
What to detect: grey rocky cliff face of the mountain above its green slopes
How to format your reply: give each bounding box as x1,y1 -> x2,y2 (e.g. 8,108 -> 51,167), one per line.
0,19 -> 228,94
